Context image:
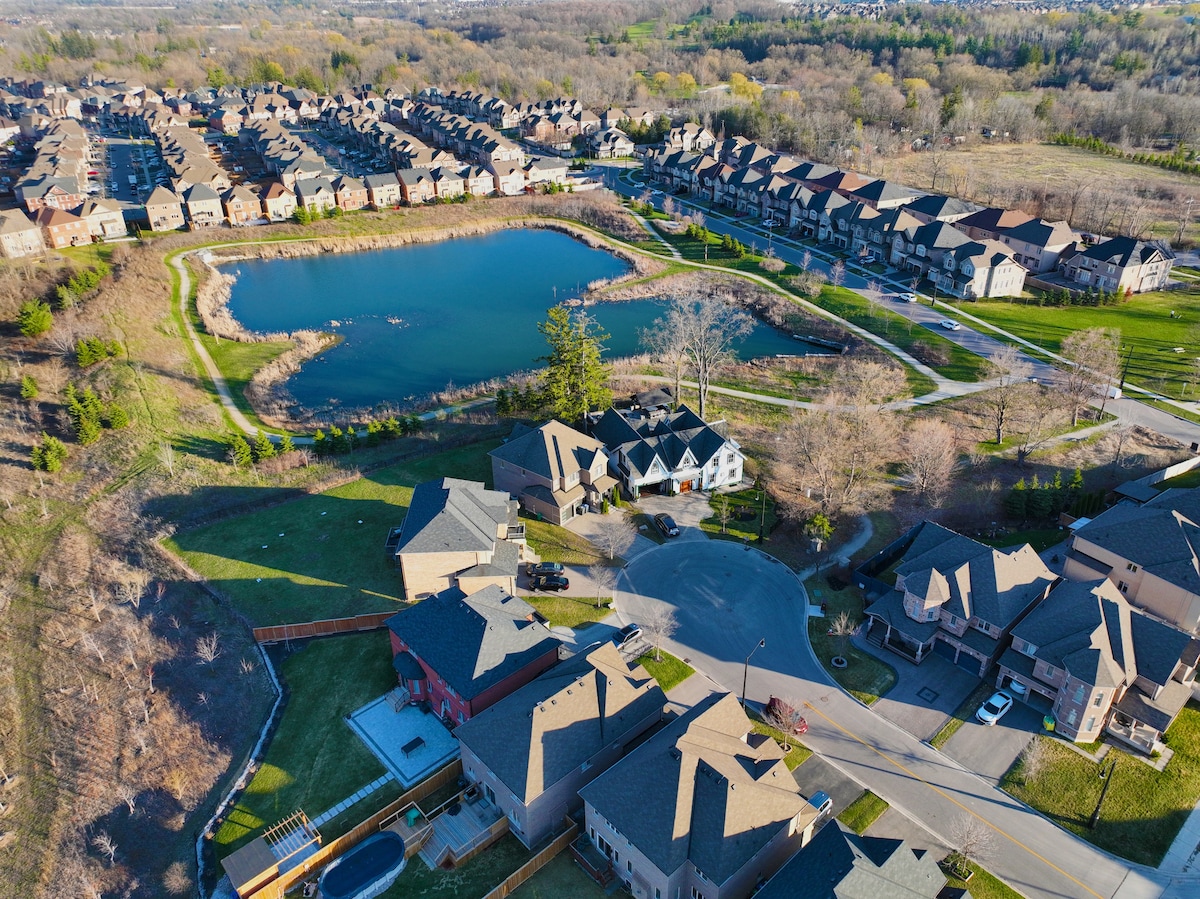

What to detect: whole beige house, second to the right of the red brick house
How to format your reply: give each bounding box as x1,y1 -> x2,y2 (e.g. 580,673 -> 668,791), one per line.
580,694 -> 818,899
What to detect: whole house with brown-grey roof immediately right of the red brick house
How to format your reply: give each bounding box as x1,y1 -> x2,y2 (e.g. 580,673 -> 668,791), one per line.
455,641 -> 667,847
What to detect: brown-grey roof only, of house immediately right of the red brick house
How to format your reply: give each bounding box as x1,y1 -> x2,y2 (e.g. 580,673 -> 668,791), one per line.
455,641 -> 667,803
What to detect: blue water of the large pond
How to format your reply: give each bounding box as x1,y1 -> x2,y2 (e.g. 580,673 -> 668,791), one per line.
226,229 -> 804,408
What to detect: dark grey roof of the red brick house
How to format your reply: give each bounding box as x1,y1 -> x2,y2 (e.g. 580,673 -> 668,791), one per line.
386,585 -> 559,700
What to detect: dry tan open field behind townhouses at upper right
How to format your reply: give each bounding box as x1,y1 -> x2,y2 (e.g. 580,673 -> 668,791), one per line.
877,143 -> 1200,242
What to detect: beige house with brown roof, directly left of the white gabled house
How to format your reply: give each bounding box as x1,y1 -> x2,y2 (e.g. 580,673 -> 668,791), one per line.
487,421 -> 617,525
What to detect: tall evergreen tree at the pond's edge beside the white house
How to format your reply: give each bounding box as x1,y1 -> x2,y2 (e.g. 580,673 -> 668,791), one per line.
538,306 -> 612,424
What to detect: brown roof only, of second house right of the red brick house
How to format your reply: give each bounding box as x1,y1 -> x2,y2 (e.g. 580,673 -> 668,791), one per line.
580,694 -> 817,885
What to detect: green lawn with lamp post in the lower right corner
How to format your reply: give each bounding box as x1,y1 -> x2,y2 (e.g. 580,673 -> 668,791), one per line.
1001,701 -> 1200,867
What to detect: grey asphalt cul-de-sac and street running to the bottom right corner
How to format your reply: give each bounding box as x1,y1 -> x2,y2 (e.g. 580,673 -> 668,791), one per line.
616,540 -> 1185,899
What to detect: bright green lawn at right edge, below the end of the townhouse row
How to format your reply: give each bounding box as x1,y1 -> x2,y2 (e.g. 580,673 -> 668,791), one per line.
962,289 -> 1200,398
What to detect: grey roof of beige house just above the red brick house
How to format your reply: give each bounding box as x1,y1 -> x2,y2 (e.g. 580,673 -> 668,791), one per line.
396,478 -> 517,555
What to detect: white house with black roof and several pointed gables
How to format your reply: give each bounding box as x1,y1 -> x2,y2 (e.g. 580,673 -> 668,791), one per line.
590,404 -> 745,498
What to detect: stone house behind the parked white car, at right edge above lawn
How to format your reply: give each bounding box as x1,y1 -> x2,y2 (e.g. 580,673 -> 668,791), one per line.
997,577 -> 1200,755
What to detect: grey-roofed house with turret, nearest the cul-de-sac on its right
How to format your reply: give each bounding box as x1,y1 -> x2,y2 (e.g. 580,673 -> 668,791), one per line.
859,521 -> 1057,676
